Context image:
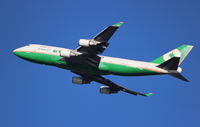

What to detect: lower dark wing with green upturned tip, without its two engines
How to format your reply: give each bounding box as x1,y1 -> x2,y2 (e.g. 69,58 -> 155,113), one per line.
73,72 -> 153,96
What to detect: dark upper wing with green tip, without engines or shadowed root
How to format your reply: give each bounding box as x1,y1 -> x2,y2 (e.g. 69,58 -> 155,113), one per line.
76,22 -> 124,56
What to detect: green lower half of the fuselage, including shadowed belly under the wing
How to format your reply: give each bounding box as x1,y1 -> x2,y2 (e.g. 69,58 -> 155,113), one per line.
15,51 -> 160,76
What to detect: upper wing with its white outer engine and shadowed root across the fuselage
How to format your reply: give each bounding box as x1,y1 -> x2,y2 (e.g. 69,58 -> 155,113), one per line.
60,22 -> 124,68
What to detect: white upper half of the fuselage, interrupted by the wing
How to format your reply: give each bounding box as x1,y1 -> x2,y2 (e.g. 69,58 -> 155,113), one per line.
14,44 -> 175,73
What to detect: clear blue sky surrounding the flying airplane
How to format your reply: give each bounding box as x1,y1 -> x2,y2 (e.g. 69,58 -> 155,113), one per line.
0,0 -> 200,127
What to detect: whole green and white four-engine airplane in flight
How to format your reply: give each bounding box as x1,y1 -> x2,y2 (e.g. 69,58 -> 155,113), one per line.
13,22 -> 193,96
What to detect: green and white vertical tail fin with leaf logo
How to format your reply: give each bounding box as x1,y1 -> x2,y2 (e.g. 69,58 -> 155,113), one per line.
151,45 -> 193,65
